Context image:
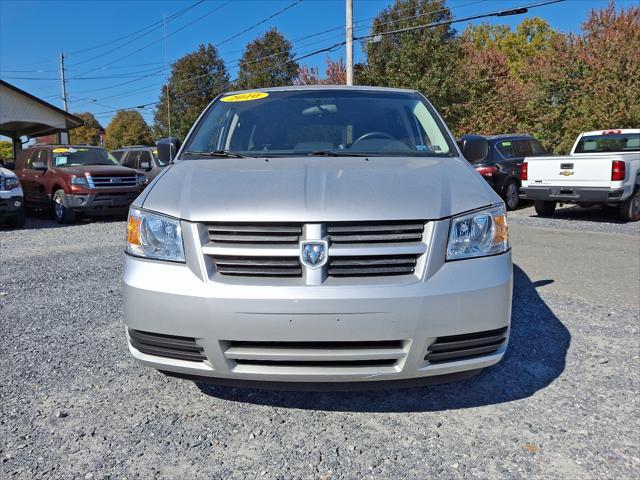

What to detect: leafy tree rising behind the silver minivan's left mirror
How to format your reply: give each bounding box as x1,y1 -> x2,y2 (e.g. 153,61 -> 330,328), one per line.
154,44 -> 229,139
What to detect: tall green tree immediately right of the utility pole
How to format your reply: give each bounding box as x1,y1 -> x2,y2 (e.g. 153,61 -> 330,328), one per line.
356,0 -> 461,126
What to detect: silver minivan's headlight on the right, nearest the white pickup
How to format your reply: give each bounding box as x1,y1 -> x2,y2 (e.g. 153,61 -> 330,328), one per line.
447,205 -> 509,260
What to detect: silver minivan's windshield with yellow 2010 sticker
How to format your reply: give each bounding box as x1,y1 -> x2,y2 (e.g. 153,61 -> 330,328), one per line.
183,89 -> 456,158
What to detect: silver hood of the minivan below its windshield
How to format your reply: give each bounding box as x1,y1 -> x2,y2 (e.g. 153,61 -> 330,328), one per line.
142,157 -> 499,223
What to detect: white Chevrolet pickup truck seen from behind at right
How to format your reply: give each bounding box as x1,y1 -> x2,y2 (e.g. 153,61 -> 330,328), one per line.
520,128 -> 640,221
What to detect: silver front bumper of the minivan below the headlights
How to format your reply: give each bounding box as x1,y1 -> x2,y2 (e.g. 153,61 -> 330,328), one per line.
124,242 -> 512,383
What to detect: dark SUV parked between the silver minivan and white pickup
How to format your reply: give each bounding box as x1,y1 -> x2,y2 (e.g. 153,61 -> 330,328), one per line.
460,135 -> 548,210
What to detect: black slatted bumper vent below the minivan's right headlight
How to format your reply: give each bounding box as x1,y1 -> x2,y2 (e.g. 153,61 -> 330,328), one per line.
424,327 -> 507,363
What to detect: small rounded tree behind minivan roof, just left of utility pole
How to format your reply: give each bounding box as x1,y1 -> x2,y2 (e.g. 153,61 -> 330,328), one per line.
237,28 -> 299,89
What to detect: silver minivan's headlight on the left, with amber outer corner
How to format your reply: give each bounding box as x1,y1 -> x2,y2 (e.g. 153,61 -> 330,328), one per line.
127,208 -> 185,262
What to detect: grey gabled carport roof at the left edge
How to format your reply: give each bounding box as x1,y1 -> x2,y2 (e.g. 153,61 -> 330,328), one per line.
0,80 -> 84,138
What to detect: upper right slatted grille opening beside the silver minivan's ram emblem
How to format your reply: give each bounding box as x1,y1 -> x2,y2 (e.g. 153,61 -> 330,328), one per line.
327,220 -> 424,243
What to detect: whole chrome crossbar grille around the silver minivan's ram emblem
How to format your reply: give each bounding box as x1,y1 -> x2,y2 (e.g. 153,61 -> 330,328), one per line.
202,220 -> 427,285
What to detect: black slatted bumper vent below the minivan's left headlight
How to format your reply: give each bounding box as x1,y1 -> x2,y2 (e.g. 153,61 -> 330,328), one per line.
128,329 -> 207,362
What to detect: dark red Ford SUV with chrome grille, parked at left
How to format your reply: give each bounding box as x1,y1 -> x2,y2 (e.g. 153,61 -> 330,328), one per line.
15,145 -> 147,223
